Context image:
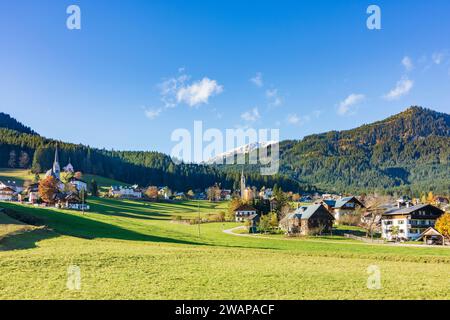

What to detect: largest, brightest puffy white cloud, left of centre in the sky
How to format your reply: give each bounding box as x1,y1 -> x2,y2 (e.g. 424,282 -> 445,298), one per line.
177,77 -> 223,107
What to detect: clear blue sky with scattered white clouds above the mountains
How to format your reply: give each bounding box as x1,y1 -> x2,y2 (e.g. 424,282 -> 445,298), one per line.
0,0 -> 450,153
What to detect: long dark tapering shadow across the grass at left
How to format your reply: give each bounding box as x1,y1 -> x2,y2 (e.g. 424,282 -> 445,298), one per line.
2,203 -> 204,245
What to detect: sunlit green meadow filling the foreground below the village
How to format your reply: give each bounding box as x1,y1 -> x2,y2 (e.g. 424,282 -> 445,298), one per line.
0,184 -> 450,299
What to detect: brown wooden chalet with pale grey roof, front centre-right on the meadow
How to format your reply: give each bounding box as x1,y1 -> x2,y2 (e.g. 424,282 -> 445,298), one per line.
280,204 -> 334,235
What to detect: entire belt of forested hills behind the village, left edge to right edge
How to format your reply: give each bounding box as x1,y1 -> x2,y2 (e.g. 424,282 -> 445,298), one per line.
0,107 -> 450,195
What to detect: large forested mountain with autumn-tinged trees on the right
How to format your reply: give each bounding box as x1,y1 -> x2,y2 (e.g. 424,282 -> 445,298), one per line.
280,107 -> 450,194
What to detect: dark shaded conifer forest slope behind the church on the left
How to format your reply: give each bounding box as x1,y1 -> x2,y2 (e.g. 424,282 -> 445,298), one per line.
0,117 -> 309,191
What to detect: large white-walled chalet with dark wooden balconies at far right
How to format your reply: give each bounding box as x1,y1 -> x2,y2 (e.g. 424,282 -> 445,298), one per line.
381,204 -> 444,240
